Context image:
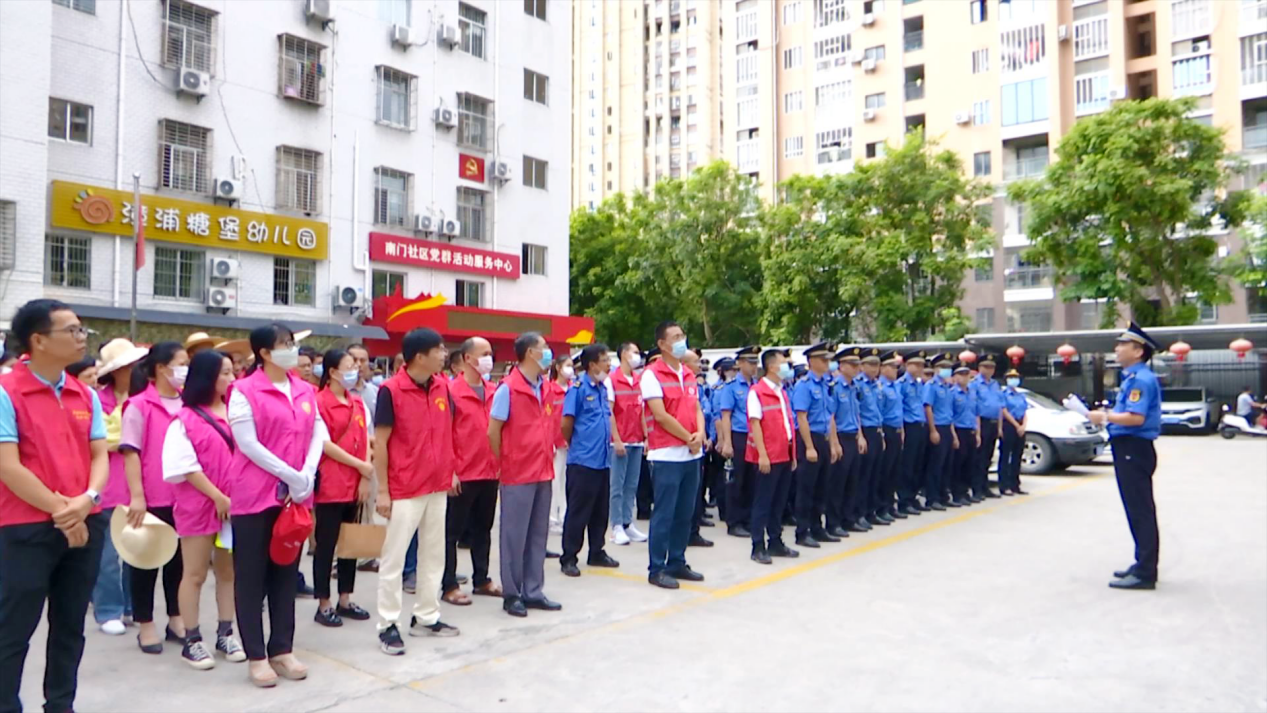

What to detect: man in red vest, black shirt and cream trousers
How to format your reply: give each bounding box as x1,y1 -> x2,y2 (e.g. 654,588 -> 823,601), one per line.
374,328 -> 460,656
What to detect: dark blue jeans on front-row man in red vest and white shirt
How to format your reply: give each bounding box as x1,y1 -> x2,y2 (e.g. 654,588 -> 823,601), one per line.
647,458 -> 699,575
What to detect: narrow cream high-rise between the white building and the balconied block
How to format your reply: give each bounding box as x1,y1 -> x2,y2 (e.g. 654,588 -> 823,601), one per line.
571,0 -> 723,209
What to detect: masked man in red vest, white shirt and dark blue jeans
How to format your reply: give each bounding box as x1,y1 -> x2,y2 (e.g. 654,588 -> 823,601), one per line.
641,320 -> 704,589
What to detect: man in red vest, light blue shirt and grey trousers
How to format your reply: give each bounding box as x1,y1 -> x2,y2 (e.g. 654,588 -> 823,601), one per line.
488,332 -> 563,617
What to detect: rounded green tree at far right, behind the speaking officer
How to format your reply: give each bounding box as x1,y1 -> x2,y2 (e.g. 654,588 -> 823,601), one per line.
1009,99 -> 1248,328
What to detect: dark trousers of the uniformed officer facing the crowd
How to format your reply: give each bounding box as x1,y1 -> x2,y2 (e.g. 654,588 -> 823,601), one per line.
1110,436 -> 1161,581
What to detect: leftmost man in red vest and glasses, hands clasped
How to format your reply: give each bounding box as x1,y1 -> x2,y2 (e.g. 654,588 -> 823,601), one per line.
0,299 -> 110,710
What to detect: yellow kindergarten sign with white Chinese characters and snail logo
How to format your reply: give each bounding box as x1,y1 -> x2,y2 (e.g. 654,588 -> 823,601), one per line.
49,181 -> 329,260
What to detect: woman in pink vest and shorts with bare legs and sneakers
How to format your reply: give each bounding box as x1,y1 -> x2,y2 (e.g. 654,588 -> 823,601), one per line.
162,350 -> 246,670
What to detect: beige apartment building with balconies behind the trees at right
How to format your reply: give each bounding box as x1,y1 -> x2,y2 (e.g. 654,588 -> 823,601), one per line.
722,0 -> 1267,332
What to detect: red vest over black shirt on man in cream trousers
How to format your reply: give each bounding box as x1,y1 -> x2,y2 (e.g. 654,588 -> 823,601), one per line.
380,369 -> 454,500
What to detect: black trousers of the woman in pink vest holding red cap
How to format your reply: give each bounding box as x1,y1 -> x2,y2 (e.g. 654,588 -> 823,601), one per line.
231,507 -> 297,661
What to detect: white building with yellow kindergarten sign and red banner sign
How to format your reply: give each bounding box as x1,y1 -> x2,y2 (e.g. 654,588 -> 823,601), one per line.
0,0 -> 582,358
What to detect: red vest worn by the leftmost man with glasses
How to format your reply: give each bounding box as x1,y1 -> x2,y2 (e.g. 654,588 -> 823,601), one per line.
0,362 -> 101,527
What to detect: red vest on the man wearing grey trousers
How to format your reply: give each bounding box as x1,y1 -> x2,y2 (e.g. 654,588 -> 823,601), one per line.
499,366 -> 554,485
